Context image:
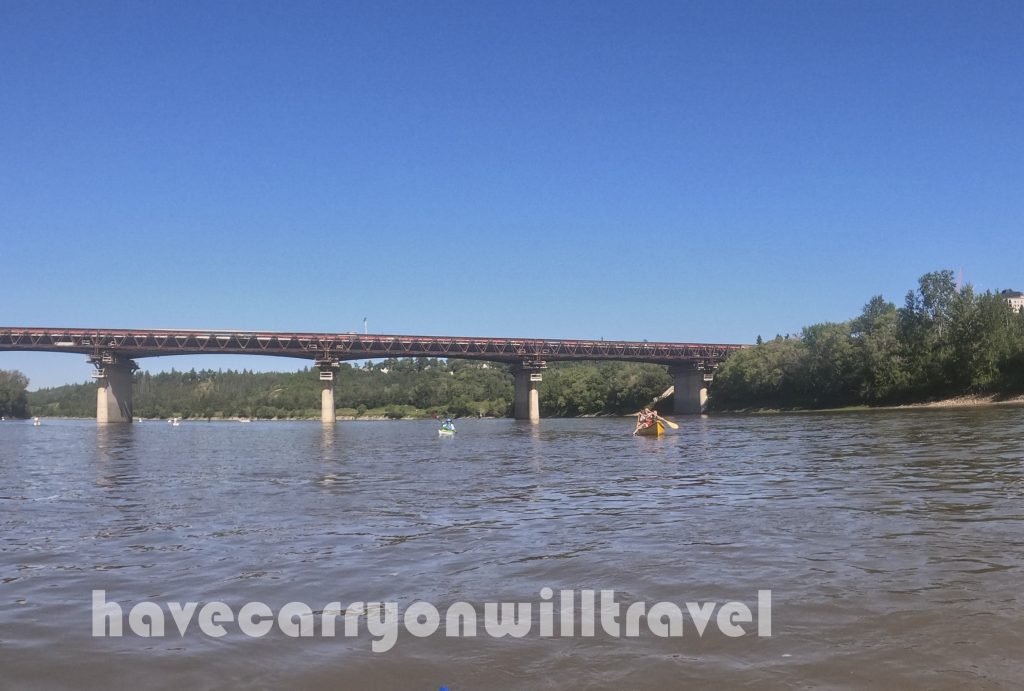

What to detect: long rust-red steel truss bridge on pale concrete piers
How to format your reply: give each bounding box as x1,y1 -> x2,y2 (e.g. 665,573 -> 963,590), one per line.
0,327 -> 744,423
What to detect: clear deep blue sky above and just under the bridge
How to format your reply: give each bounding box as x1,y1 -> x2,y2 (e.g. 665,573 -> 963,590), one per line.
0,0 -> 1024,388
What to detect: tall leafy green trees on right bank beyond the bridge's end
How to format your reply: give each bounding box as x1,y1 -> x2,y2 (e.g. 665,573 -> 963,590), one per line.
711,270 -> 1024,409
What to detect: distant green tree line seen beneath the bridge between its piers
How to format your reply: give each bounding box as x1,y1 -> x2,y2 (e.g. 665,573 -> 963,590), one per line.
22,357 -> 671,419
